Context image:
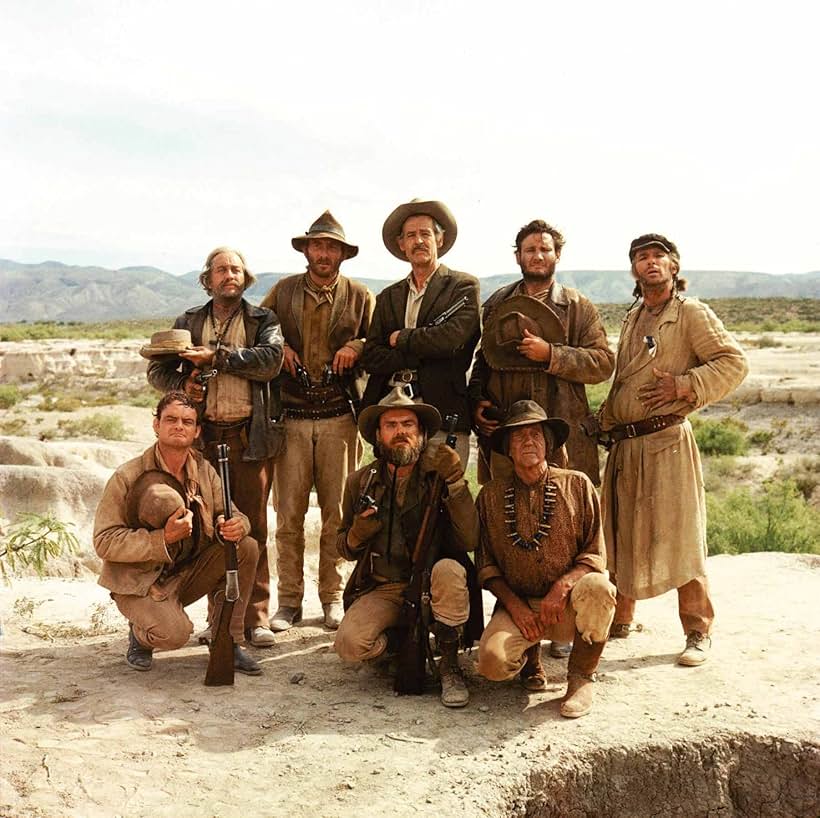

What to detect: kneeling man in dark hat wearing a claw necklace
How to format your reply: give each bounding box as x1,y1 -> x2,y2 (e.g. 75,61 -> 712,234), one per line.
477,400 -> 615,718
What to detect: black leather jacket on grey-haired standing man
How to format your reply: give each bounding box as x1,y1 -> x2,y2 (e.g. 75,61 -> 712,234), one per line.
148,298 -> 284,460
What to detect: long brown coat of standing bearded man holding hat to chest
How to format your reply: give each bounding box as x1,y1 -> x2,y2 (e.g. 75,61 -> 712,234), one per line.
470,281 -> 615,486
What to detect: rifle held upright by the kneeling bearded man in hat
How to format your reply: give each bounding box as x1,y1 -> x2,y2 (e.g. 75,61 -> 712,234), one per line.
393,415 -> 458,694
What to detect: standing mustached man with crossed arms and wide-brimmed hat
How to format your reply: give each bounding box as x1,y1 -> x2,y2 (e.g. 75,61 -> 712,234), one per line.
362,199 -> 479,465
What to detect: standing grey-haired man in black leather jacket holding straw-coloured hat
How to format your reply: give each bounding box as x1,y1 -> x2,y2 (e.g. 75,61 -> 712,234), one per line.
148,247 -> 284,647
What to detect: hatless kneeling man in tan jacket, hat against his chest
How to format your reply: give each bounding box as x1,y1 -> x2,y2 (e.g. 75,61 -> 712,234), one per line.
94,391 -> 262,676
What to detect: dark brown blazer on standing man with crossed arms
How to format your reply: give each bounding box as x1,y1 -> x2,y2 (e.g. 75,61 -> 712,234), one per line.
362,264 -> 479,431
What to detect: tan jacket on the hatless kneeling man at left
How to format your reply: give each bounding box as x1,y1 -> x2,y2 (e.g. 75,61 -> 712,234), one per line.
94,446 -> 251,596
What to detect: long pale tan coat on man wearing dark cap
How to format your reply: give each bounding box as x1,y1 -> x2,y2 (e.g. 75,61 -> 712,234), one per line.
601,297 -> 748,599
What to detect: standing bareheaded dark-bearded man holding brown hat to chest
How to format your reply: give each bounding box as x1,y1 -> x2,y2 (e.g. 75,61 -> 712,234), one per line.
470,219 -> 615,486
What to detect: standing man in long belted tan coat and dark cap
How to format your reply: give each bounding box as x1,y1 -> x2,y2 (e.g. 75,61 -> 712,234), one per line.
601,233 -> 748,666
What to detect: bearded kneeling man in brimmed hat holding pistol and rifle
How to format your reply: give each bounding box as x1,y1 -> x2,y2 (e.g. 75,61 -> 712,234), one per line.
336,388 -> 483,707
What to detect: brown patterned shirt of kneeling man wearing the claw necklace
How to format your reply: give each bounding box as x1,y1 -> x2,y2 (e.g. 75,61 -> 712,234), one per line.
476,467 -> 606,597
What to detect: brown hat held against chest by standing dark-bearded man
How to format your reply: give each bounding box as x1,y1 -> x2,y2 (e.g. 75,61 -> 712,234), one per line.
481,295 -> 566,371
